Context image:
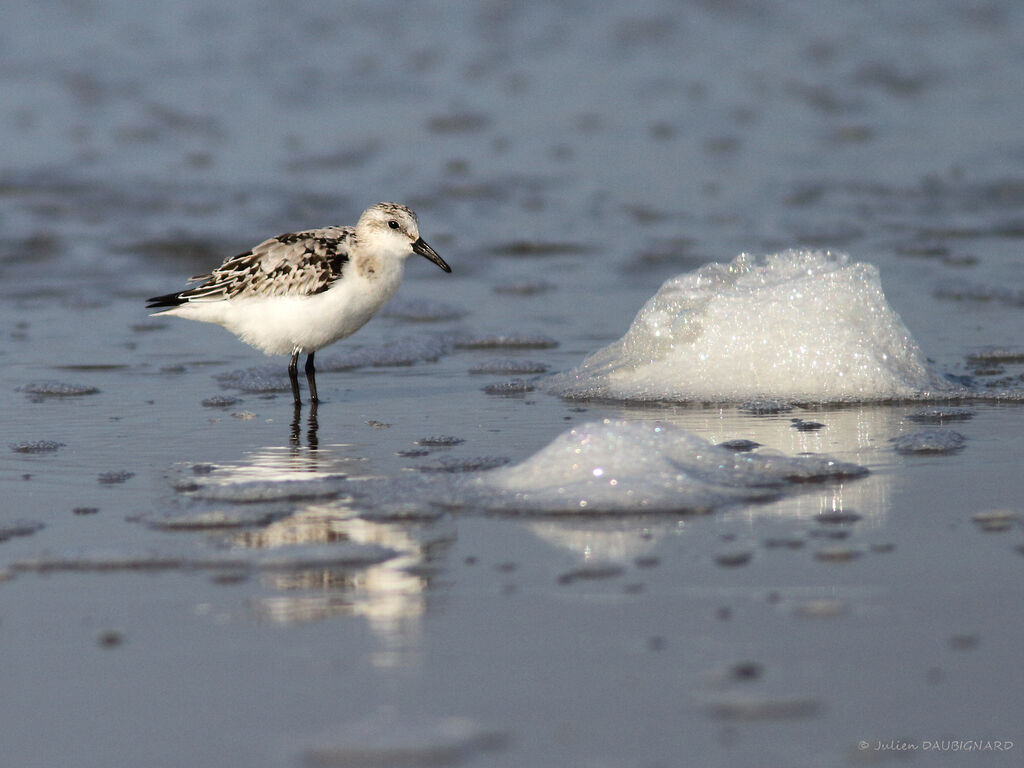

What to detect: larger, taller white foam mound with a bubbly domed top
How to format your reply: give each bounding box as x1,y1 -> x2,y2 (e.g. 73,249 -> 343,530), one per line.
546,250 -> 955,402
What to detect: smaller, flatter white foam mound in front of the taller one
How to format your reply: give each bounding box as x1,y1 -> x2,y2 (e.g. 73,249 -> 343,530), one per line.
476,419 -> 867,514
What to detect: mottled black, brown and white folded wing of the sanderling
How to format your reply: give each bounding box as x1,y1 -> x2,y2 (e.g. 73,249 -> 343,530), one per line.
178,226 -> 354,301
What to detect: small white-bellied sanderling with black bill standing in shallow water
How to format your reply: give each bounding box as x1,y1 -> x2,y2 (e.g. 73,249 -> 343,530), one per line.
146,203 -> 452,404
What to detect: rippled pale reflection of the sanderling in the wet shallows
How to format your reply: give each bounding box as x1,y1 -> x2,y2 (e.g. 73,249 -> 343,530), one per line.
193,423 -> 454,665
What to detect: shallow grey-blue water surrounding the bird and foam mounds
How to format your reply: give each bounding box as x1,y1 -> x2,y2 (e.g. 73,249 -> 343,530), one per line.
0,0 -> 1024,768
